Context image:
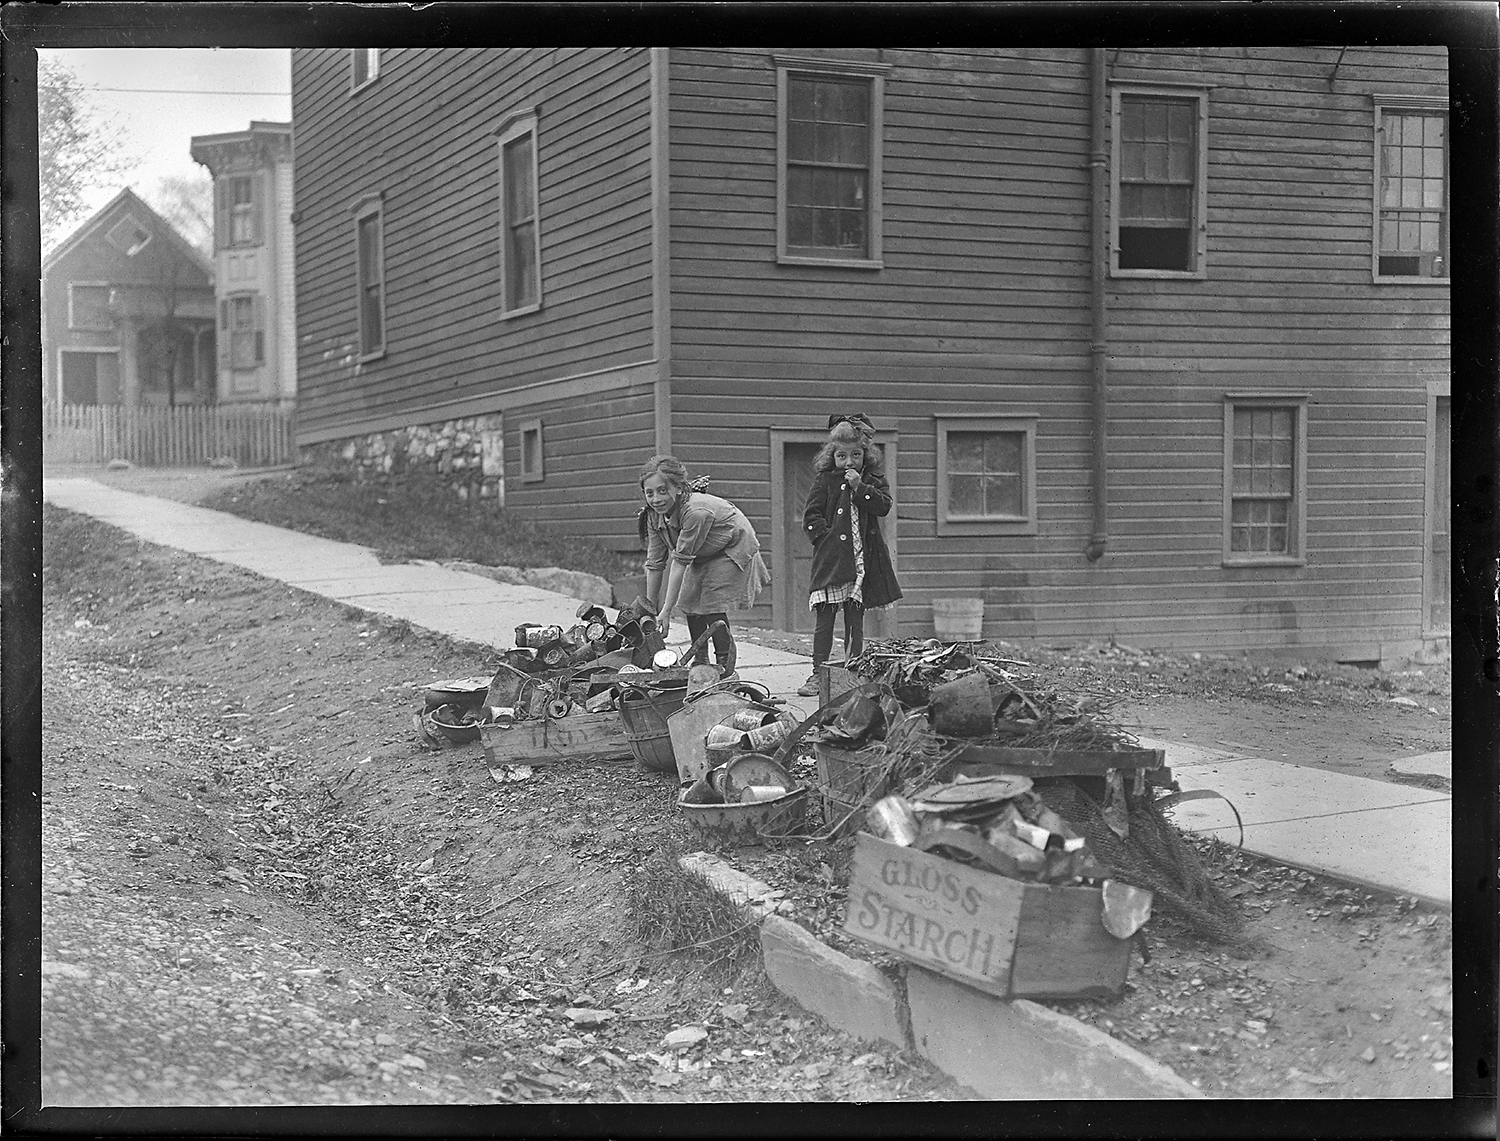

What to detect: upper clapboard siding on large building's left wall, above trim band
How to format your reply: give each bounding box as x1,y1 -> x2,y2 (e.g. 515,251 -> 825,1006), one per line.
293,48 -> 653,436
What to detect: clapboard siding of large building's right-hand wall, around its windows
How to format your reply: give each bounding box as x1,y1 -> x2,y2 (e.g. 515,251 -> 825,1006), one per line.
671,46 -> 1449,648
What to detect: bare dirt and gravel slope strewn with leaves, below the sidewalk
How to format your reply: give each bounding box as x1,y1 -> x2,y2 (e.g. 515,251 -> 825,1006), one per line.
42,510 -> 963,1105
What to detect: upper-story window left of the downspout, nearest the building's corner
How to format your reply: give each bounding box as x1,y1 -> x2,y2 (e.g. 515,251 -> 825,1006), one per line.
786,73 -> 872,258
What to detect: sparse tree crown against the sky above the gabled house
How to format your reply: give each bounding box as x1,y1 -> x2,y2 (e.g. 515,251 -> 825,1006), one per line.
36,52 -> 129,246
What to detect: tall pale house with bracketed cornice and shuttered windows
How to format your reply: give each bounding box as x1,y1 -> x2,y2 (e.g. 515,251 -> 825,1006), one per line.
191,121 -> 297,405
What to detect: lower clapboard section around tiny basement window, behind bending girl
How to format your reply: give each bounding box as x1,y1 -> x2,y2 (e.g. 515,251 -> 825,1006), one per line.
506,384 -> 656,550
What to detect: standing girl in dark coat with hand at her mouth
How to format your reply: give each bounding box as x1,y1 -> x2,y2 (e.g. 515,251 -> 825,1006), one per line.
798,412 -> 902,697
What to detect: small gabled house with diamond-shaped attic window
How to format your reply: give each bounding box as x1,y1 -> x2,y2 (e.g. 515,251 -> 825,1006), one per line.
42,189 -> 215,405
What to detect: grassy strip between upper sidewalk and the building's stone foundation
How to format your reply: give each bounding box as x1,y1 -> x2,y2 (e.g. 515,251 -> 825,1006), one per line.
203,472 -> 641,582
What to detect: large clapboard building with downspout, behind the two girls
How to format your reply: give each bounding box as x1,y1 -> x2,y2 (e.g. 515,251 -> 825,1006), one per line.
293,45 -> 1449,658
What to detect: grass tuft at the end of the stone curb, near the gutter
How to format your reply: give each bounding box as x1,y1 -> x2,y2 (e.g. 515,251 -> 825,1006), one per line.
626,841 -> 761,976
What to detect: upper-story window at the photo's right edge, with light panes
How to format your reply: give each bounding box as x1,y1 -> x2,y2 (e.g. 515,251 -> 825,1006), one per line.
1374,96 -> 1448,282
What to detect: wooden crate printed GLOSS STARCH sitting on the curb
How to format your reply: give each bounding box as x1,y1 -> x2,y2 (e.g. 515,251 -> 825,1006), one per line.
845,832 -> 1130,999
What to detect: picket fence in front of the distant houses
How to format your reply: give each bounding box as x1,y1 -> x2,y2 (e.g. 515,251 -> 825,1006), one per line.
42,402 -> 297,468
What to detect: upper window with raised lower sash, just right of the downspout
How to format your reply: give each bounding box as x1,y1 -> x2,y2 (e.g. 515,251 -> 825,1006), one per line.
1116,93 -> 1199,270
